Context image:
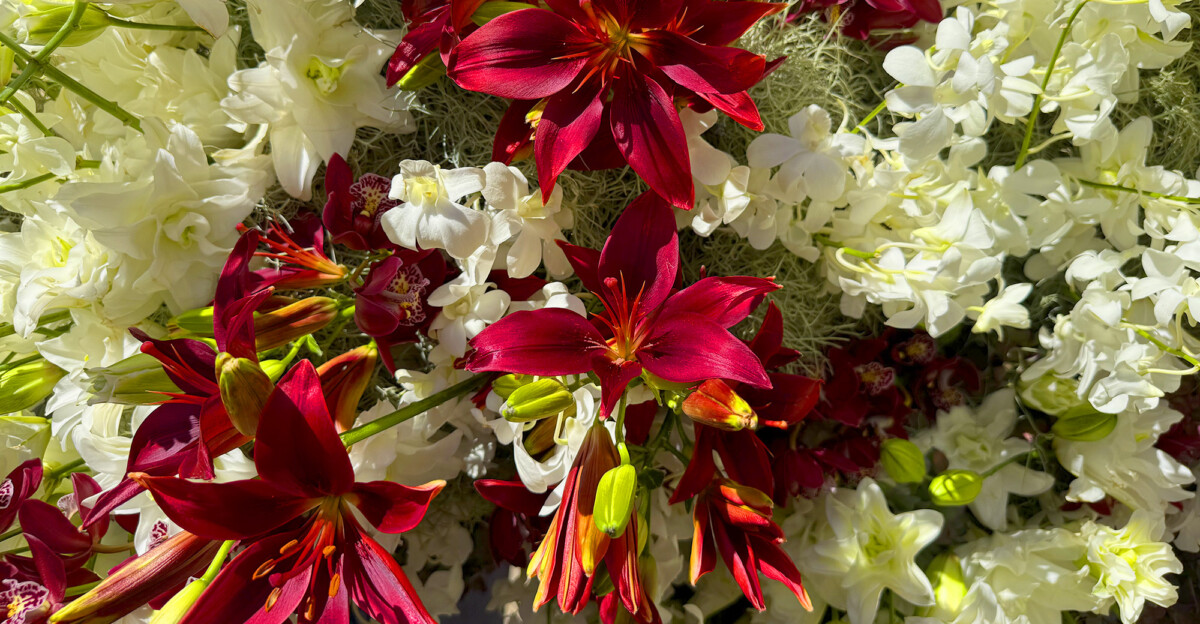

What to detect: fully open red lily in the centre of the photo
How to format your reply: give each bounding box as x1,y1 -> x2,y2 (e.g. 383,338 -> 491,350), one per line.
467,192 -> 779,416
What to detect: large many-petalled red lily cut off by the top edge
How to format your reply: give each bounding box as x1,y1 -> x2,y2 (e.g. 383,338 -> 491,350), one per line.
446,0 -> 786,210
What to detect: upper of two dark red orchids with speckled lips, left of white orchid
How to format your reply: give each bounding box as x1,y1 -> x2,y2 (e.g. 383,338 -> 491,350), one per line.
322,153 -> 412,251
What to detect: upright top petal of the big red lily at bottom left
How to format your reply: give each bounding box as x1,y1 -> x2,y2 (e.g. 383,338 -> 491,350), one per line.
254,360 -> 354,497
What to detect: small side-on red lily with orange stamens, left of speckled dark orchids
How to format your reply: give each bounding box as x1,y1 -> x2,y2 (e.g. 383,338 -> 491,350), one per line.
239,212 -> 349,290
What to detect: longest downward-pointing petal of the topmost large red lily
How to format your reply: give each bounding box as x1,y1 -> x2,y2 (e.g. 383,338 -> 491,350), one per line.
609,74 -> 695,210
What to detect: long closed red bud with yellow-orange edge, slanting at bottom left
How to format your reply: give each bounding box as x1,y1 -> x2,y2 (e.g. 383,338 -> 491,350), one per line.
50,532 -> 221,624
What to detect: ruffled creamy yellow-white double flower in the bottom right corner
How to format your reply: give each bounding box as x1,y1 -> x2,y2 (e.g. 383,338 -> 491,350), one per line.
1079,510 -> 1183,624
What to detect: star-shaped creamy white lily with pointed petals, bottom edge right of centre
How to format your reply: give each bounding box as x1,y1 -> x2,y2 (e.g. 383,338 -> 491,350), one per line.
802,479 -> 944,624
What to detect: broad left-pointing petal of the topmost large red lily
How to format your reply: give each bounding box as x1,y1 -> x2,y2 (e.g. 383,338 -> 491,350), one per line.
446,8 -> 589,100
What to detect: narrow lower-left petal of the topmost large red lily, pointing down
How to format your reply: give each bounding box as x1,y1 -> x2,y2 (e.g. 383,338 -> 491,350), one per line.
534,80 -> 607,203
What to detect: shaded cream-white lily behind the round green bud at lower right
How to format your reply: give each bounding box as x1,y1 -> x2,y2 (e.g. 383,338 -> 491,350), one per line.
923,389 -> 1054,530
